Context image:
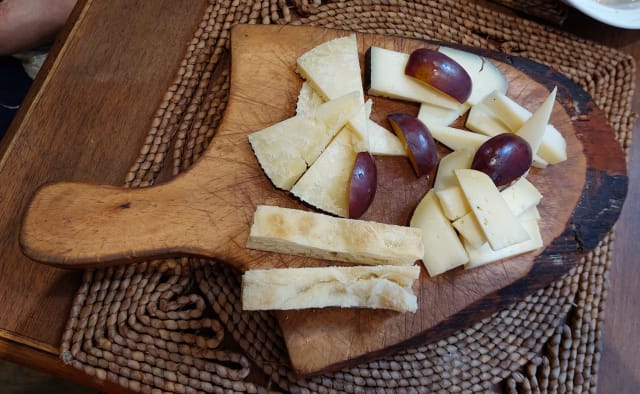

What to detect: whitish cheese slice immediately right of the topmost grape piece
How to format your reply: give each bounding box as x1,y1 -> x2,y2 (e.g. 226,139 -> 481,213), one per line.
438,47 -> 509,105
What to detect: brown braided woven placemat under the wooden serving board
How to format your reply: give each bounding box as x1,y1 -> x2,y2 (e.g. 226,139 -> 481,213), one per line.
61,0 -> 635,393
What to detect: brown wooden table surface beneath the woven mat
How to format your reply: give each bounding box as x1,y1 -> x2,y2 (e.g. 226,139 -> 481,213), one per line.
0,0 -> 640,393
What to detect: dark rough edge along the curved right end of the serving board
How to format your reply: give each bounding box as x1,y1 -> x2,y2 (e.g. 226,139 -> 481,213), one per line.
300,40 -> 629,377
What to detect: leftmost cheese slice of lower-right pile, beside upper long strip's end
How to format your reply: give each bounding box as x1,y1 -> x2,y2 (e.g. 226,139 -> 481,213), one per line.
410,189 -> 469,276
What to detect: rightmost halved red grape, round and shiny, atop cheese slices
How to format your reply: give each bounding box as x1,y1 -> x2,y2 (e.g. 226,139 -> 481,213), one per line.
471,133 -> 533,186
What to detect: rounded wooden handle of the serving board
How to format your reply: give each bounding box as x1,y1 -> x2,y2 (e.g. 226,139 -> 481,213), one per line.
20,182 -> 235,268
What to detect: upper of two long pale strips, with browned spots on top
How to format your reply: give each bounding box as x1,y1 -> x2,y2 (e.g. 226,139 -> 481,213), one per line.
247,205 -> 424,265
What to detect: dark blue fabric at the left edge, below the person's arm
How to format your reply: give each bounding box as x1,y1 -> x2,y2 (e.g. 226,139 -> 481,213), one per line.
0,56 -> 31,138
